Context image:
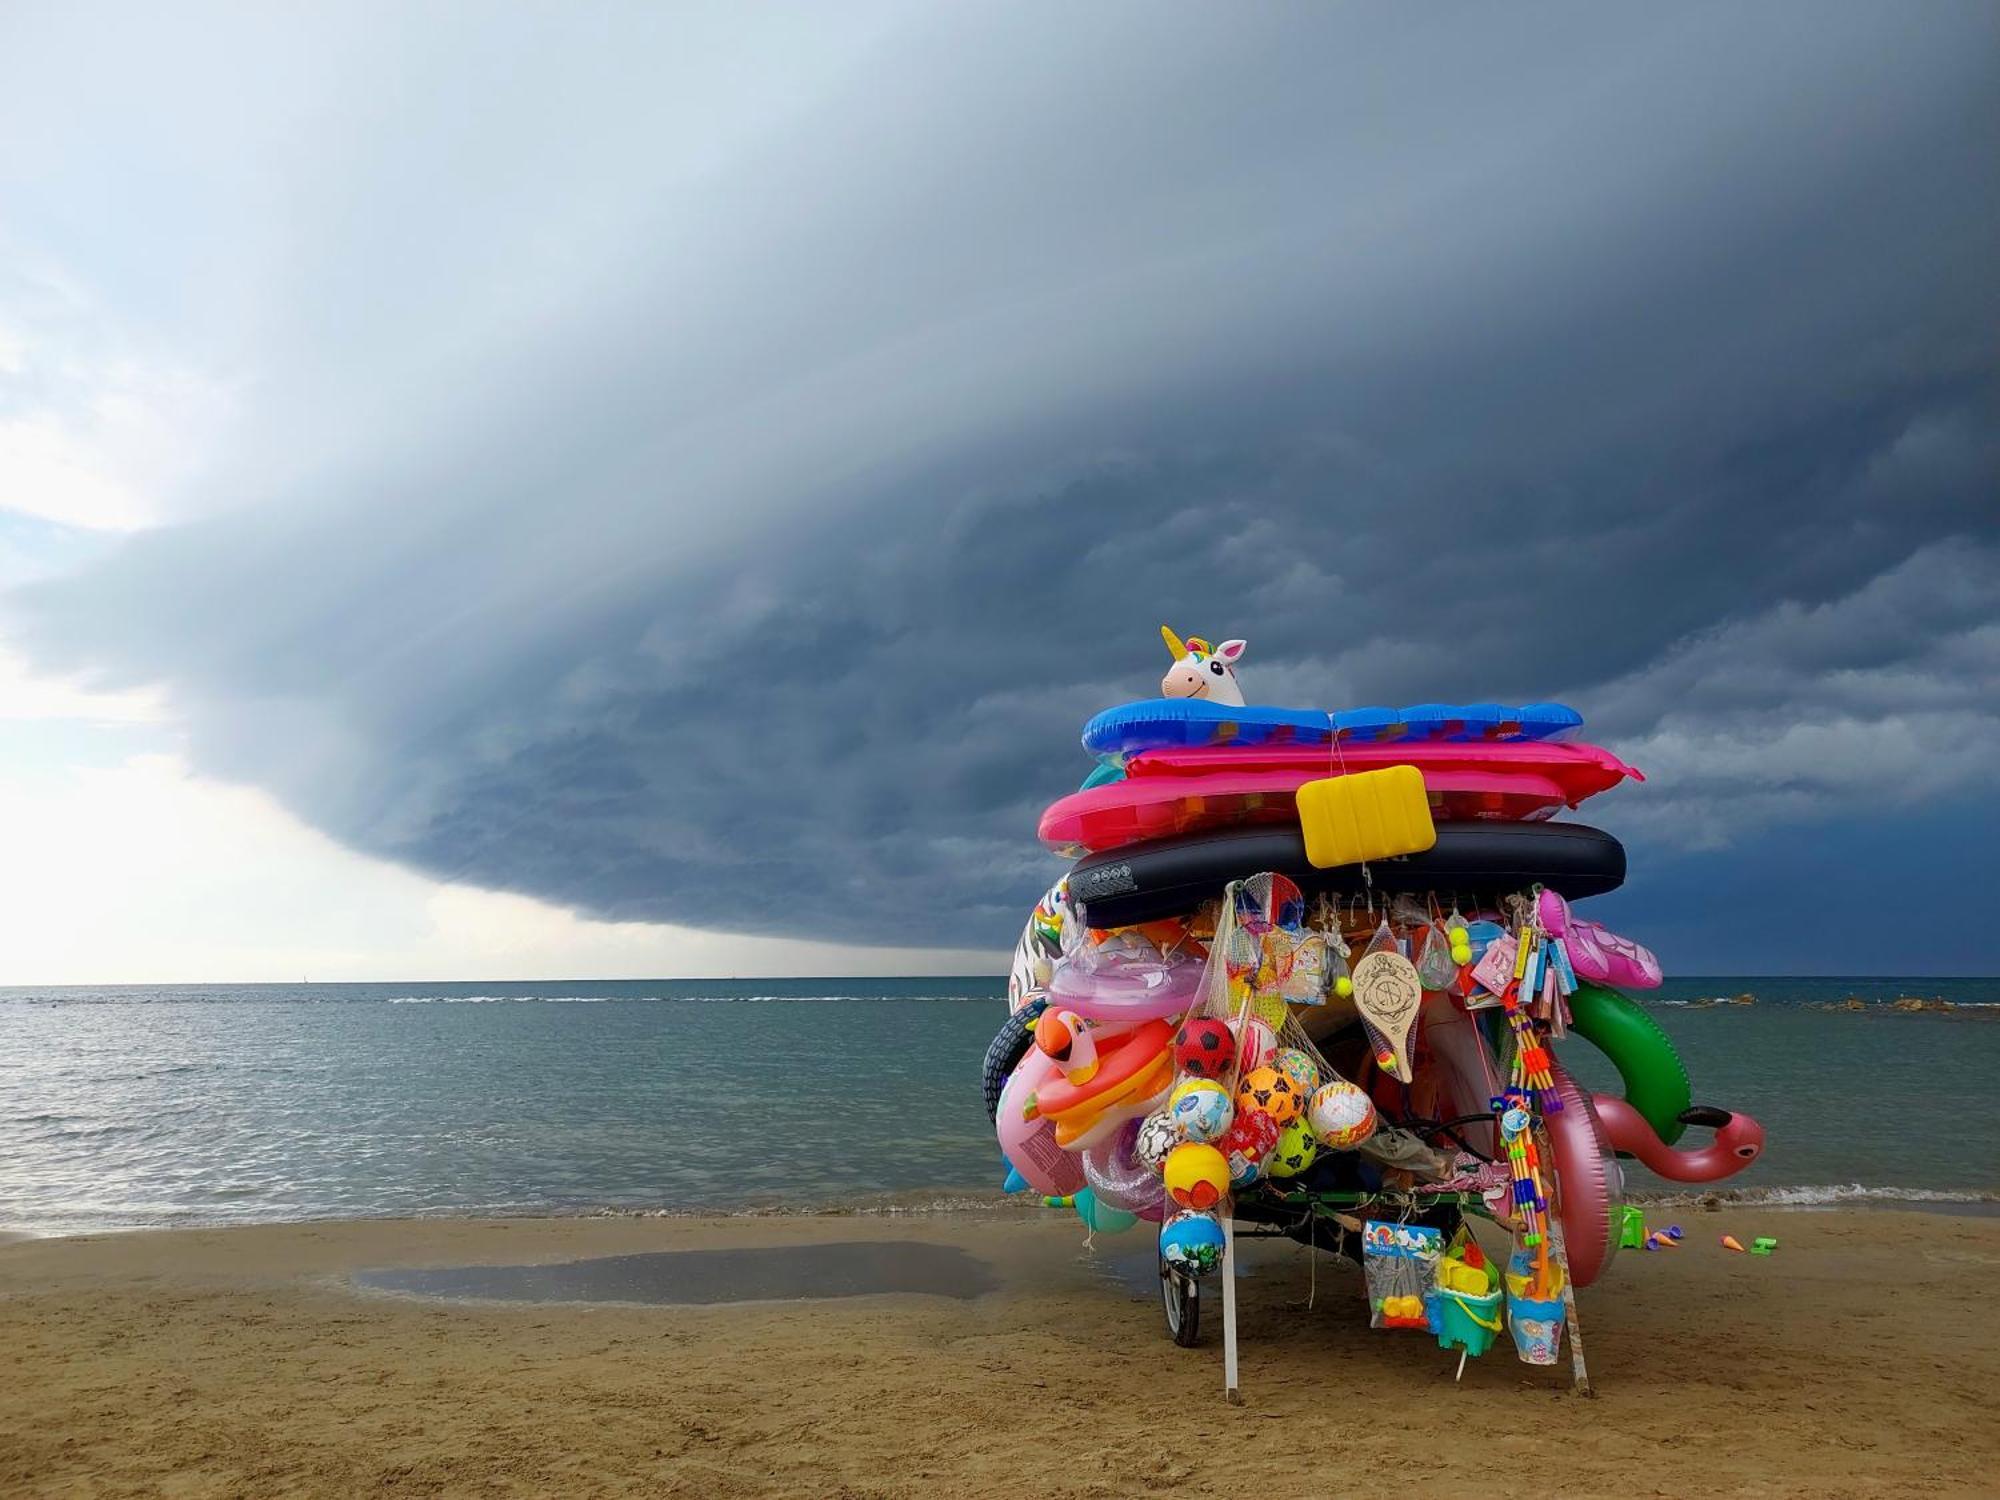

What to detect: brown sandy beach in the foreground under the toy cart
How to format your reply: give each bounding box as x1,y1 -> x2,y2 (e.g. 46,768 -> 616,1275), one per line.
0,1210 -> 2000,1500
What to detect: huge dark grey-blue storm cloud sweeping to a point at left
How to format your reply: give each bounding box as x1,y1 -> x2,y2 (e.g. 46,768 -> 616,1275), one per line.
14,6 -> 2000,944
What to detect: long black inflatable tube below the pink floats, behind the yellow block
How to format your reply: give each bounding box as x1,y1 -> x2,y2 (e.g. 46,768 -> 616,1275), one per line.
1070,822 -> 1626,928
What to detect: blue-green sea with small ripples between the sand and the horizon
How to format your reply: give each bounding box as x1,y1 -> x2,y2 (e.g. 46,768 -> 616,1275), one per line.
0,978 -> 2000,1234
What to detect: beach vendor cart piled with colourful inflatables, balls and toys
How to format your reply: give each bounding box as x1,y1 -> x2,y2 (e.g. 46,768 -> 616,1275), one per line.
984,630 -> 1762,1388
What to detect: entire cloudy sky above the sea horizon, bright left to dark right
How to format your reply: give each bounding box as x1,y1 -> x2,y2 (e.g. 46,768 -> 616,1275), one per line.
0,0 -> 2000,980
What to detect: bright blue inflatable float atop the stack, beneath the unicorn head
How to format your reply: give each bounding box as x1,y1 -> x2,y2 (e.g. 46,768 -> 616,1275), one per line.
1084,698 -> 1584,760
